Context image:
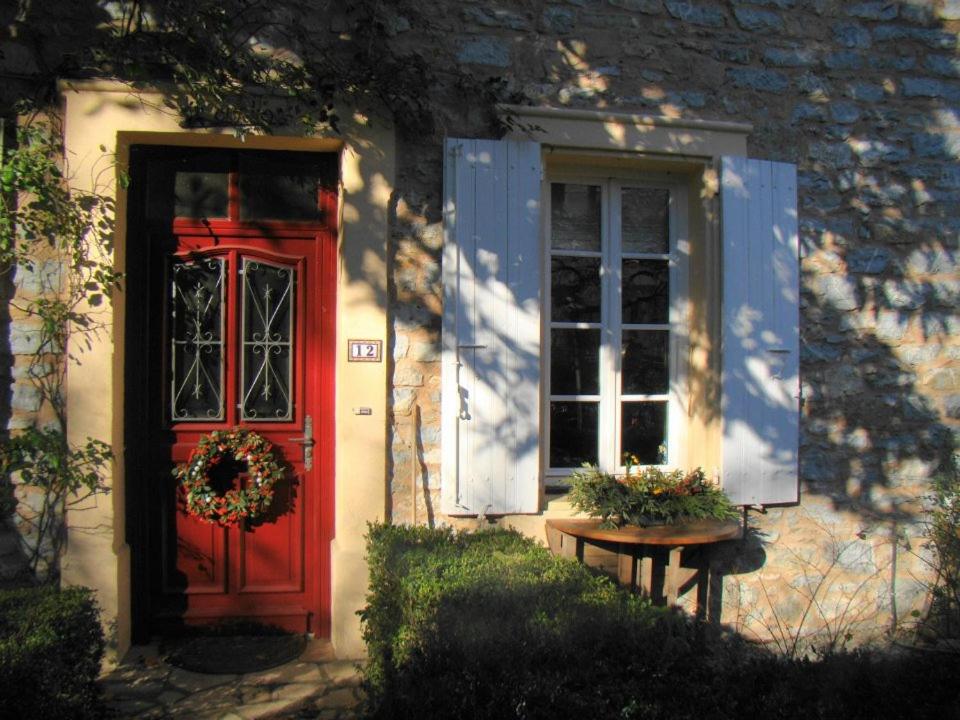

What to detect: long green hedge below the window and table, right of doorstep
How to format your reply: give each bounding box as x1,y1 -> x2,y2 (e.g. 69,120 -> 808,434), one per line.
361,525 -> 960,720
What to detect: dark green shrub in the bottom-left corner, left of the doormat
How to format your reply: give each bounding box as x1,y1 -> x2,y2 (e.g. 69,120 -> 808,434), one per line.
0,587 -> 104,720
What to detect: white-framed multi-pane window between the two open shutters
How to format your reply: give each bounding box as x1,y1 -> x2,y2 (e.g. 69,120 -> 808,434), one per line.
544,175 -> 689,481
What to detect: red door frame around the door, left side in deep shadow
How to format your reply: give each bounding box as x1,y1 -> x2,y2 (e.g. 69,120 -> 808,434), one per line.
123,143 -> 339,642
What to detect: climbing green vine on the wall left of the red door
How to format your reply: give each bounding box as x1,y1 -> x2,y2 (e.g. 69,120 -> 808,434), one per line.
0,122 -> 121,581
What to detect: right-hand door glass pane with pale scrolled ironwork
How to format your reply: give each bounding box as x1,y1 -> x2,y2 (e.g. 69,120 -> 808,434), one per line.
240,258 -> 295,421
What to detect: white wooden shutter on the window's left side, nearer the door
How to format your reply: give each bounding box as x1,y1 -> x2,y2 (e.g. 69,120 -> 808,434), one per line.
441,138 -> 541,515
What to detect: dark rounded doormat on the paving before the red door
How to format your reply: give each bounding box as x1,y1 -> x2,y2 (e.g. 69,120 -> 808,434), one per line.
161,634 -> 307,675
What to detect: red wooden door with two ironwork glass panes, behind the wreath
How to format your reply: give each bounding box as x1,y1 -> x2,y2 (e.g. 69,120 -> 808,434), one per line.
136,148 -> 336,635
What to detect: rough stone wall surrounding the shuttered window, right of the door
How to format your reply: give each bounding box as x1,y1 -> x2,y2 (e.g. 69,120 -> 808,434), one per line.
382,0 -> 960,640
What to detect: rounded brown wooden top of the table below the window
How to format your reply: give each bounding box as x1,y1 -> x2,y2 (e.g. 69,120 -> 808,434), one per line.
547,518 -> 743,545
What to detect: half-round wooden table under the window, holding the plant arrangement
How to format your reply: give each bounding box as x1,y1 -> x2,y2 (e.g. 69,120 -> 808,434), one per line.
547,519 -> 743,616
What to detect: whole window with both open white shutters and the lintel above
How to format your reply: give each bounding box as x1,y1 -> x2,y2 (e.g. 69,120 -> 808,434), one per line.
441,136 -> 800,515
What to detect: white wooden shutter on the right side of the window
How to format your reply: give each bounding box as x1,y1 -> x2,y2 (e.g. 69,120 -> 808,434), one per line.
721,157 -> 800,504
